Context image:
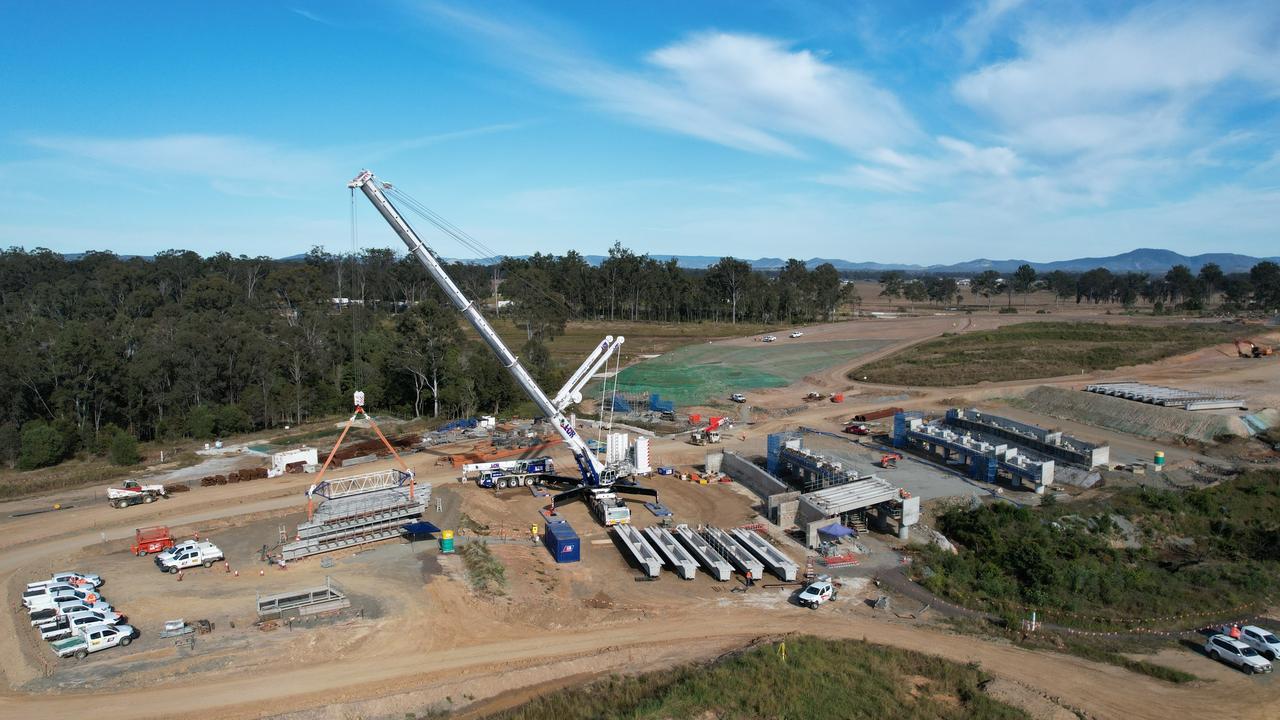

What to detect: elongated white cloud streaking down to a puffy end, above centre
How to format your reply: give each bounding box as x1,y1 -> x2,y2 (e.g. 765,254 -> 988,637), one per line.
414,5 -> 916,156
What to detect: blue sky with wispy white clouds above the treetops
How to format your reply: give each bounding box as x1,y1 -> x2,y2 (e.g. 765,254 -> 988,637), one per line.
0,0 -> 1280,264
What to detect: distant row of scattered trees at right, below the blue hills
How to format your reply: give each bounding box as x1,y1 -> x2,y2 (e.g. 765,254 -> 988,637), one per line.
879,260 -> 1280,313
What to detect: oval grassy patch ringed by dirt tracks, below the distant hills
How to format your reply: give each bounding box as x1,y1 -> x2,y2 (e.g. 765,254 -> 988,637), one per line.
850,323 -> 1239,386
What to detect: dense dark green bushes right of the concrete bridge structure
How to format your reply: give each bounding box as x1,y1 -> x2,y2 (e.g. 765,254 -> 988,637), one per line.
918,471 -> 1280,626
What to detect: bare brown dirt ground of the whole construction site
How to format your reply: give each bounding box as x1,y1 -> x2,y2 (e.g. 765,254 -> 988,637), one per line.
0,315 -> 1280,720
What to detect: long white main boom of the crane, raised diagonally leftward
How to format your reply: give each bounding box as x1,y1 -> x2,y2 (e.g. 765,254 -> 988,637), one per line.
347,170 -> 611,487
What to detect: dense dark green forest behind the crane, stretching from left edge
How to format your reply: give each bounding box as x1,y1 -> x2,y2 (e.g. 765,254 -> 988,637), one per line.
0,245 -> 851,469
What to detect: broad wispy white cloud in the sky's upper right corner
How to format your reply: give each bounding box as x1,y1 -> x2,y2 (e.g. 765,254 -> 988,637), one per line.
955,4 -> 1280,154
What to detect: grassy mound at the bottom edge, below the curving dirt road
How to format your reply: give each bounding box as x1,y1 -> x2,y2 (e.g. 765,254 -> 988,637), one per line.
476,637 -> 1027,720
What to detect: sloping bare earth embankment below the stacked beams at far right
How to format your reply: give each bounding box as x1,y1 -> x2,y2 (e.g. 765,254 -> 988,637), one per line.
1010,386 -> 1249,442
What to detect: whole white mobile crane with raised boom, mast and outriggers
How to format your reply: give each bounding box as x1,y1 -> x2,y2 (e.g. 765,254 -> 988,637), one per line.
347,170 -> 658,525
